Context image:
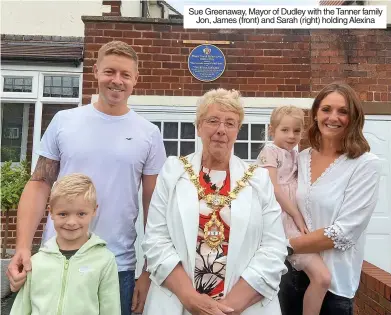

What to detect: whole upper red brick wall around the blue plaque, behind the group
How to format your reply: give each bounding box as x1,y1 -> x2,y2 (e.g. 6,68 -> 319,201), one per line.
83,17 -> 391,108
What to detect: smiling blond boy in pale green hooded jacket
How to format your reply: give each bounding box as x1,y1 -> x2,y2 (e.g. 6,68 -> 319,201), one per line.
11,174 -> 121,315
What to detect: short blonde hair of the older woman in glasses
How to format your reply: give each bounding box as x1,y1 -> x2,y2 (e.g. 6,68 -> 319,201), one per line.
195,88 -> 244,127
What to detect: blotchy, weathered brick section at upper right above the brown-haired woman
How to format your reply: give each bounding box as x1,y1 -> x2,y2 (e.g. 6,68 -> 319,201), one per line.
311,29 -> 391,102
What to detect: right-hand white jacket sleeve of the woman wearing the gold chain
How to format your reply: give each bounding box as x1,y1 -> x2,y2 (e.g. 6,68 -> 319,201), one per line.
242,169 -> 288,305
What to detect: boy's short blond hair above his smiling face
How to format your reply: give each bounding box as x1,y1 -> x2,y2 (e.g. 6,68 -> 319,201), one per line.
49,173 -> 97,207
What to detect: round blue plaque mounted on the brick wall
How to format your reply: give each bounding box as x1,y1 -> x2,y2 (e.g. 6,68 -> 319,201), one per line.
187,45 -> 225,82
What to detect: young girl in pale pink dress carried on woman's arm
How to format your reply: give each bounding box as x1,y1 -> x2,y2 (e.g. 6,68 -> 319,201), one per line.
258,106 -> 331,315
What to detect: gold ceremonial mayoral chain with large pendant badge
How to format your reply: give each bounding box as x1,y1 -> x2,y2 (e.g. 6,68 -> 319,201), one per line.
179,156 -> 258,249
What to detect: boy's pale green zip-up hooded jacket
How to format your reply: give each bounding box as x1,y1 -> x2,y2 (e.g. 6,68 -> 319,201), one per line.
11,233 -> 121,315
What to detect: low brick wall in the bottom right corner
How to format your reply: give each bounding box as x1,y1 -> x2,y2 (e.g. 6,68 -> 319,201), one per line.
354,261 -> 391,315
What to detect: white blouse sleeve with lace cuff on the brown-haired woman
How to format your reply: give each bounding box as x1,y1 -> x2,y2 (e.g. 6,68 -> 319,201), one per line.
324,155 -> 381,250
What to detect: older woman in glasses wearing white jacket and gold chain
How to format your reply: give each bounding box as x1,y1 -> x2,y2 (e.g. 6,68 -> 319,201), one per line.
142,89 -> 287,315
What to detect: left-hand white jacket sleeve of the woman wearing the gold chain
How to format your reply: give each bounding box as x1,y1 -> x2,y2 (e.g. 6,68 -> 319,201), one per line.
141,157 -> 180,293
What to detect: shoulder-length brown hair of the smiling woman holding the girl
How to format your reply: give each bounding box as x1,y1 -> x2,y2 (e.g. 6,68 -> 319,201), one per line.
308,83 -> 370,159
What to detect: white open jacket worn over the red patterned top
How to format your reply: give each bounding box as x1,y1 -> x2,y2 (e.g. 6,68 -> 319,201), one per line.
142,152 -> 287,315
